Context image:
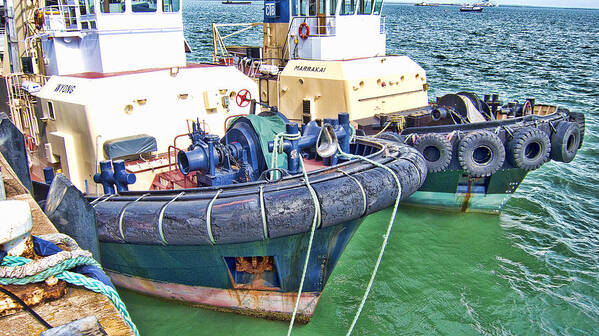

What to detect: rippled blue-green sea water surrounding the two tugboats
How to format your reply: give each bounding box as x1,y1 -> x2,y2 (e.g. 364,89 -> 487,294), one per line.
121,0 -> 599,335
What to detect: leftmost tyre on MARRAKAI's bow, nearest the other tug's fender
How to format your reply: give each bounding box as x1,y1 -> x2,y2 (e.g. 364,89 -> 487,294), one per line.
413,133 -> 453,173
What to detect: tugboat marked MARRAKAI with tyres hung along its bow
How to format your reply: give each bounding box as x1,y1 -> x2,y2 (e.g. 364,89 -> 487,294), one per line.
213,0 -> 585,213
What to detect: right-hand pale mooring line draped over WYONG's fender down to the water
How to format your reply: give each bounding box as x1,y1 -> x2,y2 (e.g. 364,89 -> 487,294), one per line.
337,144 -> 401,336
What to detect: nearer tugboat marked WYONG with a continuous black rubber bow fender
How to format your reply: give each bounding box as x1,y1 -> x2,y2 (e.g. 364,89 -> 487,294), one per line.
2,0 -> 427,322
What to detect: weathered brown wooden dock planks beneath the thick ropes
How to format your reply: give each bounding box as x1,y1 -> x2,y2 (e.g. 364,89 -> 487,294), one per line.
0,154 -> 134,336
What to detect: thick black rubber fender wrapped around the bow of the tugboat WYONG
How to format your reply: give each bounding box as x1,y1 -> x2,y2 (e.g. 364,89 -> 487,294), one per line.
92,140 -> 427,245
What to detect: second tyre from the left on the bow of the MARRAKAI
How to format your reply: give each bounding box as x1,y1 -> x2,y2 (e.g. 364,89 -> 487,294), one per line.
458,131 -> 505,177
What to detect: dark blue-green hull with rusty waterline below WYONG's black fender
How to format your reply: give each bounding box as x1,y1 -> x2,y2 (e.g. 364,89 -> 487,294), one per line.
101,219 -> 361,323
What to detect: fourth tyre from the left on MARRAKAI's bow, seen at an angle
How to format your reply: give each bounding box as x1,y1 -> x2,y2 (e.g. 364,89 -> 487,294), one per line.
551,121 -> 580,163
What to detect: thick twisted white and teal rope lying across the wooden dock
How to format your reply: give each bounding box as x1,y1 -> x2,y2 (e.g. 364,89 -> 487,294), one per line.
0,238 -> 139,336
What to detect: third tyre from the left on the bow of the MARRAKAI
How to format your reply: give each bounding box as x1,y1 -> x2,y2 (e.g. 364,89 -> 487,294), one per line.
507,127 -> 551,170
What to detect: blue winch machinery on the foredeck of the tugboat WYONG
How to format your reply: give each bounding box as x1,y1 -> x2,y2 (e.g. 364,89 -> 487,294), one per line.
177,113 -> 352,186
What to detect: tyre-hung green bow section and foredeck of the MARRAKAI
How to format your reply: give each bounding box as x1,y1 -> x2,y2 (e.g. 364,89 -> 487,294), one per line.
378,92 -> 585,212
